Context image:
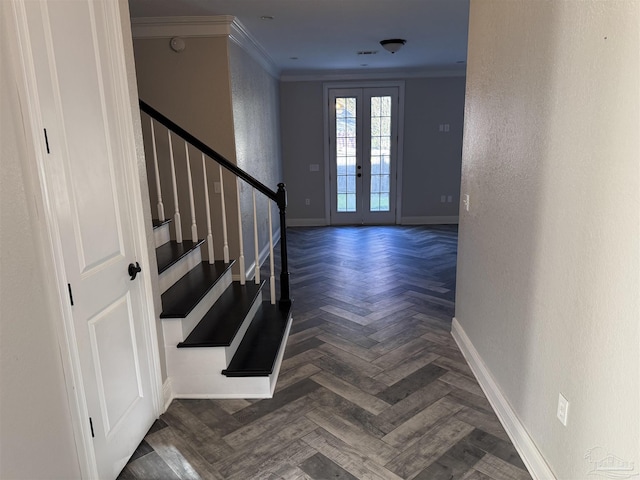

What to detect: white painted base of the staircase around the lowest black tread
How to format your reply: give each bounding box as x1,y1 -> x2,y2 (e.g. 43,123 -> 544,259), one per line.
165,314 -> 293,399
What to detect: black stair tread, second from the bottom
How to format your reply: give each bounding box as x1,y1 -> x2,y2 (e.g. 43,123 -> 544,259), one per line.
178,282 -> 264,348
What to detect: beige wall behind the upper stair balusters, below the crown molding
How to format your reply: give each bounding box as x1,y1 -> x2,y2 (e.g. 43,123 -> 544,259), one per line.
133,33 -> 238,273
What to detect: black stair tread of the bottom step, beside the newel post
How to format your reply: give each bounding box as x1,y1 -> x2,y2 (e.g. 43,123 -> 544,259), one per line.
222,302 -> 291,377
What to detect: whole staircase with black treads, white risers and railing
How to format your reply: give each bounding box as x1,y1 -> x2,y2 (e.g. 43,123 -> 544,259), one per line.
140,102 -> 292,398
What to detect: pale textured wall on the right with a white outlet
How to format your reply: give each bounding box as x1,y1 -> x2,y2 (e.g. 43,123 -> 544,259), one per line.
456,0 -> 640,479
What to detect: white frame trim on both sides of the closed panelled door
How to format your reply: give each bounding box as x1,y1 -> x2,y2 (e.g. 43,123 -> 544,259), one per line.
6,0 -> 163,478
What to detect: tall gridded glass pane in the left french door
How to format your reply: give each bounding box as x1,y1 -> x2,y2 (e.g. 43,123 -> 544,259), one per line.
336,97 -> 357,212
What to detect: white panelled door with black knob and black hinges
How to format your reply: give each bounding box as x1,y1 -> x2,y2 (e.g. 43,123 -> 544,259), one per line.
16,0 -> 157,479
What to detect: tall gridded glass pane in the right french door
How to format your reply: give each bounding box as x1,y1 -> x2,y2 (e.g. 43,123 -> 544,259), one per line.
369,96 -> 391,212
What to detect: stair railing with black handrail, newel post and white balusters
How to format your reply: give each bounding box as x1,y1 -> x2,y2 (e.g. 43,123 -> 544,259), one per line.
140,100 -> 291,308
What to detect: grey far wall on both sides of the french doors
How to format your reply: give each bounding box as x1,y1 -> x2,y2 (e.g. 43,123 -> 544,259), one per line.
280,77 -> 465,224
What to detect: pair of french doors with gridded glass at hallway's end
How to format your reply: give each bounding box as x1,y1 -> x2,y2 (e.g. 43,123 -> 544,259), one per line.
329,87 -> 399,225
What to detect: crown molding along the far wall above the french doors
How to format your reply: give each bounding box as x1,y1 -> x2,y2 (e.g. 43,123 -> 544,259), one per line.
280,68 -> 467,82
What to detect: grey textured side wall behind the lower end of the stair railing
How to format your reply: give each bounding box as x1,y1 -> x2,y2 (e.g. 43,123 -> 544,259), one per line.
229,42 -> 284,265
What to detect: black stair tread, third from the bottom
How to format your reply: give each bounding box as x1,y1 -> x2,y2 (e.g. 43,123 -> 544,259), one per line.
160,260 -> 234,318
